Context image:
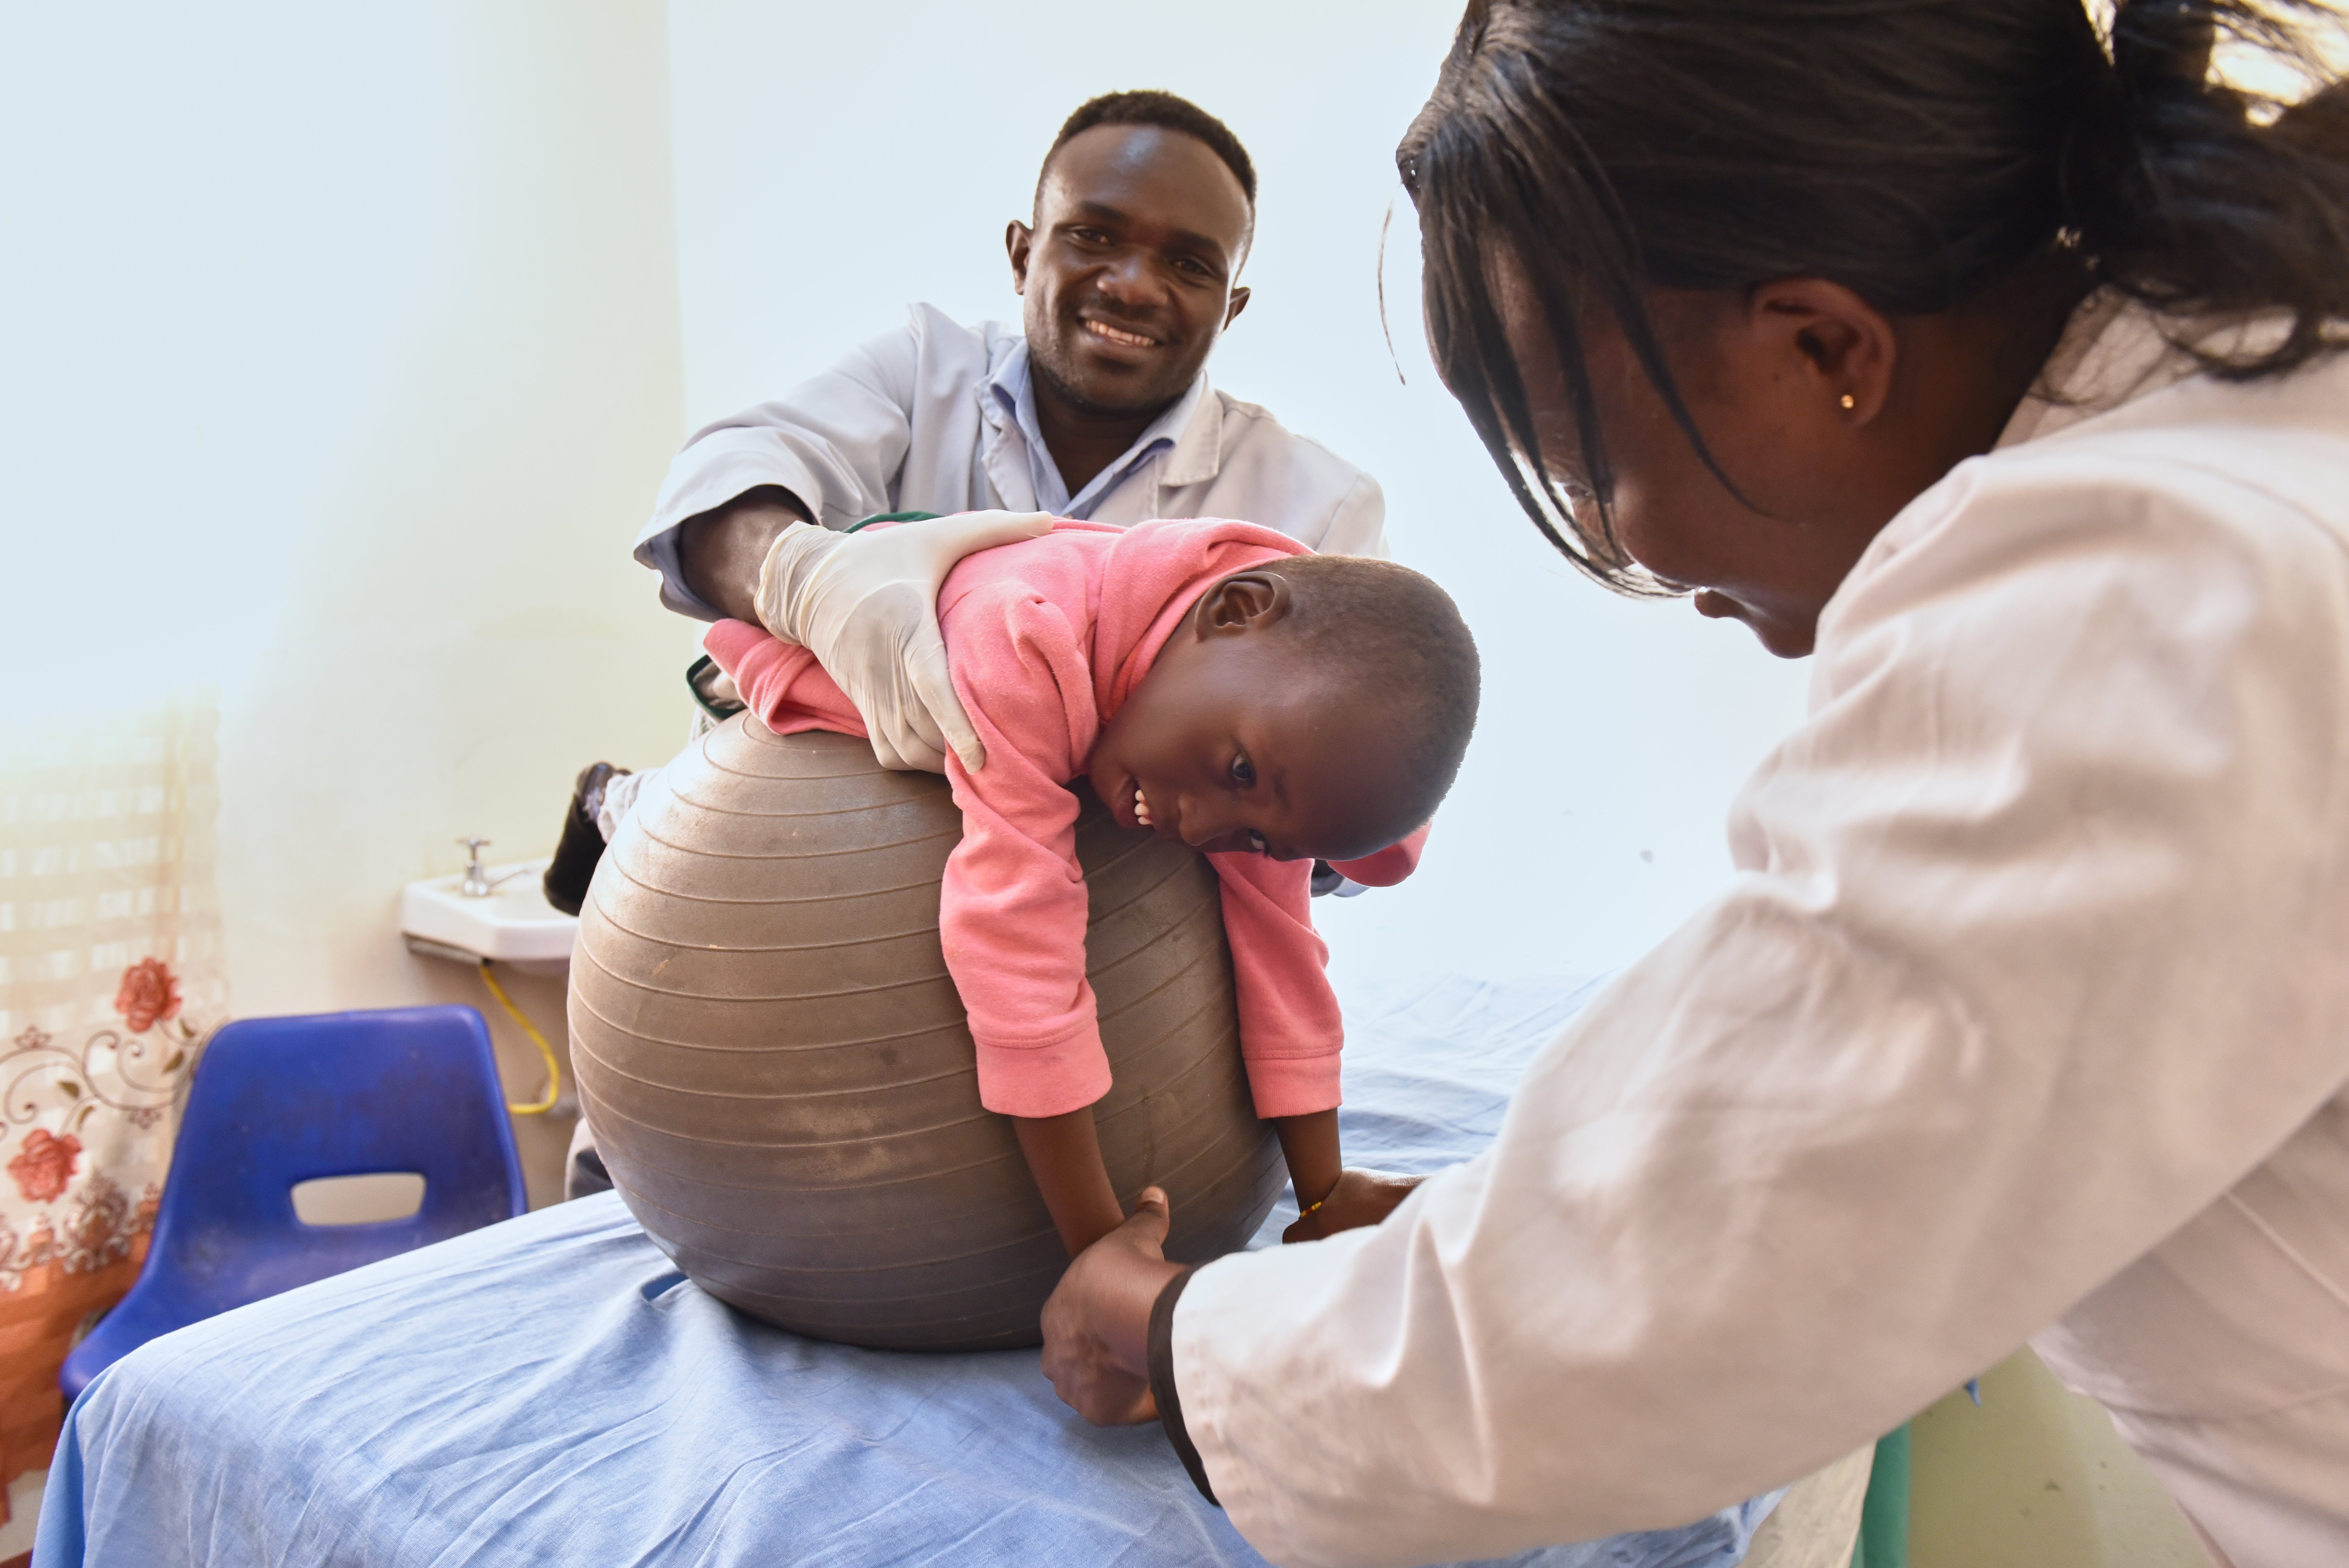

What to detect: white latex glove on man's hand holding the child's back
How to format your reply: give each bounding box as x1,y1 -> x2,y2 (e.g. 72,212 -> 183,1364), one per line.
759,512 -> 1052,772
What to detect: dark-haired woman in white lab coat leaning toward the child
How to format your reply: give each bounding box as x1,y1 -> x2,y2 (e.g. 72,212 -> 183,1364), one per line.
733,0 -> 2349,1568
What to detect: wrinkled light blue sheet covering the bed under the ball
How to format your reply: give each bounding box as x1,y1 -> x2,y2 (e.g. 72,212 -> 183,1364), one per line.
33,976 -> 1776,1568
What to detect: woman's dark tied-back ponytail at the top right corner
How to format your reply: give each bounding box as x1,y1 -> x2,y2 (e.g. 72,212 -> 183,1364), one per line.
2062,0 -> 2349,378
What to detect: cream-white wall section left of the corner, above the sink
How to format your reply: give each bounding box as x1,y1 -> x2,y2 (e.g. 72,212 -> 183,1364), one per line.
0,0 -> 693,1197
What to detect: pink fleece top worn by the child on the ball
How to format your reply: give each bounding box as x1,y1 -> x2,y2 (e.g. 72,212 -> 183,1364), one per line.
702,521 -> 1421,1117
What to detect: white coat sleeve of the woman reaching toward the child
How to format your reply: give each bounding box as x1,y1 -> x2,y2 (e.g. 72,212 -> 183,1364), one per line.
1172,444 -> 2349,1568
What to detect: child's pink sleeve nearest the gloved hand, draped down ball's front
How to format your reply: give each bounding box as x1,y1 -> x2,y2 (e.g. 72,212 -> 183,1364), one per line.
937,592 -> 1109,1117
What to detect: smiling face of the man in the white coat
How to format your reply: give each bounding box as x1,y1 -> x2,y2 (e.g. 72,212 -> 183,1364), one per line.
1010,125 -> 1255,413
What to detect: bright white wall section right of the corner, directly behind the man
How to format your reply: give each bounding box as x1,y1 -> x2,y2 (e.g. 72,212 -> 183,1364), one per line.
670,0 -> 1804,972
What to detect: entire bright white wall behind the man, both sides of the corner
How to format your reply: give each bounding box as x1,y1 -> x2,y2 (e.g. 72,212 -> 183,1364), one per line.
0,0 -> 1802,1221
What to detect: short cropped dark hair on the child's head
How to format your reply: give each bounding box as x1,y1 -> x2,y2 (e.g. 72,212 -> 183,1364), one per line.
1257,556 -> 1480,838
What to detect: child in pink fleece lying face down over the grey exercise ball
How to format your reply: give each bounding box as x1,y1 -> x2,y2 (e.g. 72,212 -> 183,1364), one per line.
705,519 -> 1477,1256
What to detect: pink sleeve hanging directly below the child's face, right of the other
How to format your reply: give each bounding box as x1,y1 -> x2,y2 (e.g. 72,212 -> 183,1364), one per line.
1207,854 -> 1346,1117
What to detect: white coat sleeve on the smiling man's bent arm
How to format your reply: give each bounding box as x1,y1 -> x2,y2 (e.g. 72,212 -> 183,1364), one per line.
636,317 -> 921,620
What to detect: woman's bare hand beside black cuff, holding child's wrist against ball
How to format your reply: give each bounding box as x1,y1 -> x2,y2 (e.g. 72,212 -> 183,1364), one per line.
1043,1188 -> 1182,1427
